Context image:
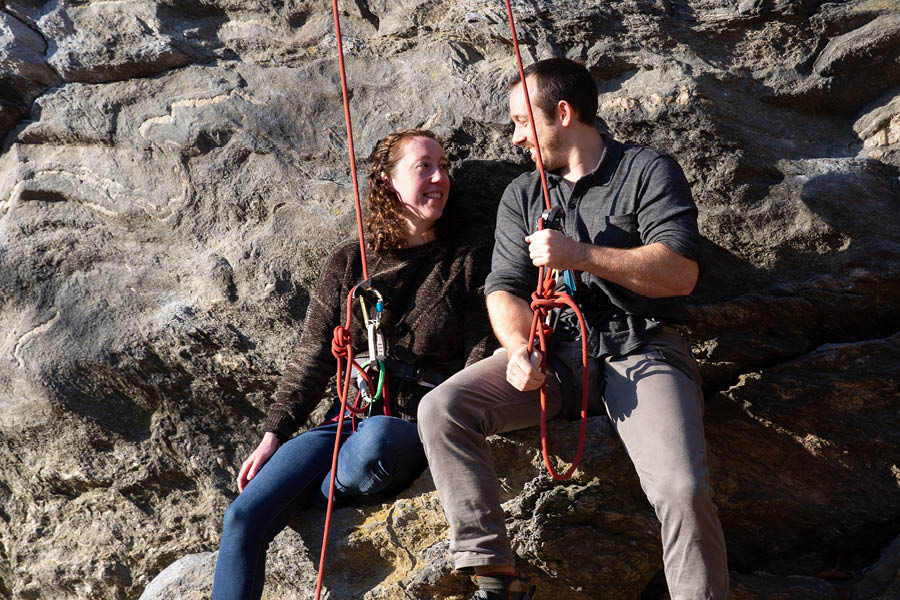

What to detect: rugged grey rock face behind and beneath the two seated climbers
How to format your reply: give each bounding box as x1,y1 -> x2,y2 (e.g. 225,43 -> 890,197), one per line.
0,0 -> 900,600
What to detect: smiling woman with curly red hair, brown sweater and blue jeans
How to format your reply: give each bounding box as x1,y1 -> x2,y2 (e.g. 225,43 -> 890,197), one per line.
213,130 -> 490,600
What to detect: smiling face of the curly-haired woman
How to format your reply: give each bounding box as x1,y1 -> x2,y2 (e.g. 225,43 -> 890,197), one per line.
387,137 -> 450,234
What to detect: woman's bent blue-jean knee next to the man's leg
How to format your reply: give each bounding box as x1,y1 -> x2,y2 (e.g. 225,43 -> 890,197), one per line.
318,415 -> 428,503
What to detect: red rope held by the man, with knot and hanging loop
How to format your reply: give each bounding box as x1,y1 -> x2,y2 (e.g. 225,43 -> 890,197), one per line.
506,0 -> 589,481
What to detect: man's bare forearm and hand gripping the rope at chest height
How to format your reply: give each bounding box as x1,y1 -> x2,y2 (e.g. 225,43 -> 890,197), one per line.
524,229 -> 699,296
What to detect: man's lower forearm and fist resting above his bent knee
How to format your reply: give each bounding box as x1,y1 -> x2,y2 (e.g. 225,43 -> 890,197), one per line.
487,290 -> 546,392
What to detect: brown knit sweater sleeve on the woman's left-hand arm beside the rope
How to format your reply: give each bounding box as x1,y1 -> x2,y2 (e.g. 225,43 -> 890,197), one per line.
265,245 -> 352,442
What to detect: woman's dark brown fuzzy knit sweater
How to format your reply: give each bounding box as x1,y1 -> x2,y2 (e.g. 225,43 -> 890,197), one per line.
265,240 -> 494,441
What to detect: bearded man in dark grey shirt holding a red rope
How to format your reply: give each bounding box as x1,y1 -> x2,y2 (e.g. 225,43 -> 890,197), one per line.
418,58 -> 728,600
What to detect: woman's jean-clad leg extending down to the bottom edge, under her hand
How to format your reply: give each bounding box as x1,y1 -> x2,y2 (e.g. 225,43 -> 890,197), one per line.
213,422 -> 350,600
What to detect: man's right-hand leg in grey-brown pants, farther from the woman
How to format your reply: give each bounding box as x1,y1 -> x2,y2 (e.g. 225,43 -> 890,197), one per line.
604,328 -> 728,600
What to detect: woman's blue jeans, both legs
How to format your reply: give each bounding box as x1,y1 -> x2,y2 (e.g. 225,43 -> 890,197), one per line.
213,415 -> 427,600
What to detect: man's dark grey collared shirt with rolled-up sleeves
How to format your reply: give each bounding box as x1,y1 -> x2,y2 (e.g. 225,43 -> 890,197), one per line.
485,135 -> 700,357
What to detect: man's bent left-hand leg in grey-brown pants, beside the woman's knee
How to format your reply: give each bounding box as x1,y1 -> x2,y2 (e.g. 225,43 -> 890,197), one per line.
417,352 -> 560,570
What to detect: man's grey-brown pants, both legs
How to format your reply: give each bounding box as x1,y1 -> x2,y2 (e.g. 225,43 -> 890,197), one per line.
418,327 -> 728,600
